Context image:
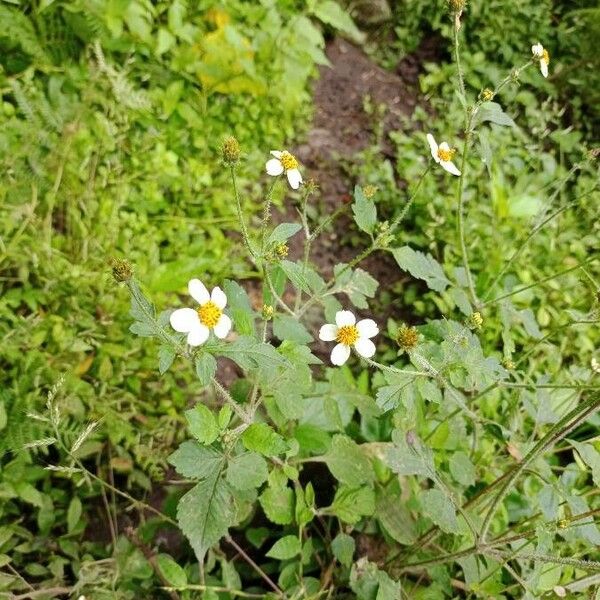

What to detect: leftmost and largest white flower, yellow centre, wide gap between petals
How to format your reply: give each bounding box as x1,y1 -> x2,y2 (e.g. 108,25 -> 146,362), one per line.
170,279 -> 231,346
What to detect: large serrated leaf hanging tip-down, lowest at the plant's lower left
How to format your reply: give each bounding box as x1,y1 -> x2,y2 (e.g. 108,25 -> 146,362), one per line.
177,463 -> 235,562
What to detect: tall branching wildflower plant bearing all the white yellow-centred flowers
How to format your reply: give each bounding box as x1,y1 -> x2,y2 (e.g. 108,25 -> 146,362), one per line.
58,2 -> 600,600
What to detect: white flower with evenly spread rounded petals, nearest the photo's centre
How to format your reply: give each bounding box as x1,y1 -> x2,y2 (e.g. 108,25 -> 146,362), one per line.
319,310 -> 379,366
